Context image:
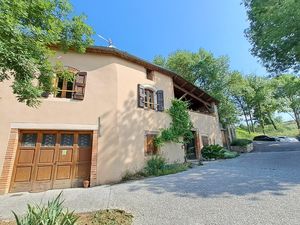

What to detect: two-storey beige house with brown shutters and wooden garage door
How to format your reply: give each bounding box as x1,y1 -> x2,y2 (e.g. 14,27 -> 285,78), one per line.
0,47 -> 222,194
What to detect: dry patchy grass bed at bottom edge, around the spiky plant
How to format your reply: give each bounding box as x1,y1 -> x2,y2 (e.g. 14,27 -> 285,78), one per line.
0,209 -> 133,225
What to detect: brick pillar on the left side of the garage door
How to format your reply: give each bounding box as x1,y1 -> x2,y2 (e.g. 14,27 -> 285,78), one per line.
0,129 -> 18,194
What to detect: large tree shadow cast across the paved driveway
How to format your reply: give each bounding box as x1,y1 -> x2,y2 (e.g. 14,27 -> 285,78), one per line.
128,145 -> 300,200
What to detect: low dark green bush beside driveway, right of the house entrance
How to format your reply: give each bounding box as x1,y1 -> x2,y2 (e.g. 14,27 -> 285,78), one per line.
201,145 -> 239,159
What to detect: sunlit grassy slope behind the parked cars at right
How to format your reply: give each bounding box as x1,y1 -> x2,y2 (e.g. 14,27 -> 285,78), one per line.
236,122 -> 299,140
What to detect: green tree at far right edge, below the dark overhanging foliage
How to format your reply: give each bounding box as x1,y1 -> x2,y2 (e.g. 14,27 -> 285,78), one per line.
276,74 -> 300,129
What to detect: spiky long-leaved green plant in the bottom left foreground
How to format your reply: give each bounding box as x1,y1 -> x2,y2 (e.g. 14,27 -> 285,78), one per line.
13,193 -> 79,225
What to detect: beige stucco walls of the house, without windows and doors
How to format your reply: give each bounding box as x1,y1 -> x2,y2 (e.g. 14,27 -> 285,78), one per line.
0,50 -> 221,189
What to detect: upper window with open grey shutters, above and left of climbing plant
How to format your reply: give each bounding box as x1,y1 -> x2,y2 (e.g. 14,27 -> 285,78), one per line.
138,84 -> 164,112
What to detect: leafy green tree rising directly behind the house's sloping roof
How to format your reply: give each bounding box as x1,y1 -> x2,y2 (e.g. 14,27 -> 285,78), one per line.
153,49 -> 237,126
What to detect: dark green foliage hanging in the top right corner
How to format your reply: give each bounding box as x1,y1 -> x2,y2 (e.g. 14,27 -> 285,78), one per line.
244,0 -> 300,73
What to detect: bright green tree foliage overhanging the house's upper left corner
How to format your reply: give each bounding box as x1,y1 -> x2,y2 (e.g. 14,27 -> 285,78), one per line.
0,0 -> 93,106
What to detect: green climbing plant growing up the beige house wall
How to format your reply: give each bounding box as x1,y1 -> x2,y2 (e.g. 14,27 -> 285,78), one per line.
154,99 -> 193,147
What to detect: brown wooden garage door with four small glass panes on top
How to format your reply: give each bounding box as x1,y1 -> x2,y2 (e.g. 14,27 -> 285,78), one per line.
10,131 -> 92,192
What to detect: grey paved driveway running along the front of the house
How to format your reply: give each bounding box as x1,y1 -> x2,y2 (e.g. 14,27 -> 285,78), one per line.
0,143 -> 300,225
